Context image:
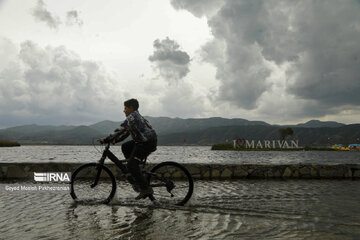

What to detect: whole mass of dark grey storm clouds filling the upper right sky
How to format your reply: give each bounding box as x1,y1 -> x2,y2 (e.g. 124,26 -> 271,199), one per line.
172,0 -> 360,115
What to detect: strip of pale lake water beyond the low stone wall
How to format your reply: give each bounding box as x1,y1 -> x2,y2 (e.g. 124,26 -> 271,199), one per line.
0,145 -> 360,164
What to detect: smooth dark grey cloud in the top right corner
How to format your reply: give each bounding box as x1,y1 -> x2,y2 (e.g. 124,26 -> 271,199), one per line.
287,1 -> 360,107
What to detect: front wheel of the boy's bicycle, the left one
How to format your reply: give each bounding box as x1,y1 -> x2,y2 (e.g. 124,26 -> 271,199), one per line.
70,163 -> 116,203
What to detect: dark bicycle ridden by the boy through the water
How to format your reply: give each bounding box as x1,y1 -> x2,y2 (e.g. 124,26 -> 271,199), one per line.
70,143 -> 194,206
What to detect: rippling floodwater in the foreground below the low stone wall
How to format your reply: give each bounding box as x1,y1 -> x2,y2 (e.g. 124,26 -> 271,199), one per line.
0,180 -> 360,240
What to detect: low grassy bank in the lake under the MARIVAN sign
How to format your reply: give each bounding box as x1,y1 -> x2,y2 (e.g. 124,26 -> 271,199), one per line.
211,143 -> 335,151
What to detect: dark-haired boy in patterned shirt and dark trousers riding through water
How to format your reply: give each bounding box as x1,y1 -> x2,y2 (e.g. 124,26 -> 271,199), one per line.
100,98 -> 157,200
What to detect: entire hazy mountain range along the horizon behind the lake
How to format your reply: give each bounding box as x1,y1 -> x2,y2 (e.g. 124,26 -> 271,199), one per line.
0,117 -> 360,146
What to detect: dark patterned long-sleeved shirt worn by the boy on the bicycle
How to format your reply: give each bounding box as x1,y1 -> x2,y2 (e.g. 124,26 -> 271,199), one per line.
109,111 -> 157,142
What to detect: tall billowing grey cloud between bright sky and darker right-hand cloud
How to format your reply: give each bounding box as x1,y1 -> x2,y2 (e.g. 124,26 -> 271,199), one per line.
203,1 -> 271,109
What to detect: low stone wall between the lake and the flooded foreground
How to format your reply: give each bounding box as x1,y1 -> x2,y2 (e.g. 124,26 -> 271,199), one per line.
0,162 -> 360,180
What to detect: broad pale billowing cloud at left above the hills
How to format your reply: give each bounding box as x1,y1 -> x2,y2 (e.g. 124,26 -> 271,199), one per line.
0,41 -> 122,126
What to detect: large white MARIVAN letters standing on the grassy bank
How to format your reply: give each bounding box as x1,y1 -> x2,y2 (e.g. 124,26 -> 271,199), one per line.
234,138 -> 299,149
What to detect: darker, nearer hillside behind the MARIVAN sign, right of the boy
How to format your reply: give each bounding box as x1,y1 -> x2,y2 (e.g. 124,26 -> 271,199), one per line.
159,124 -> 360,146
